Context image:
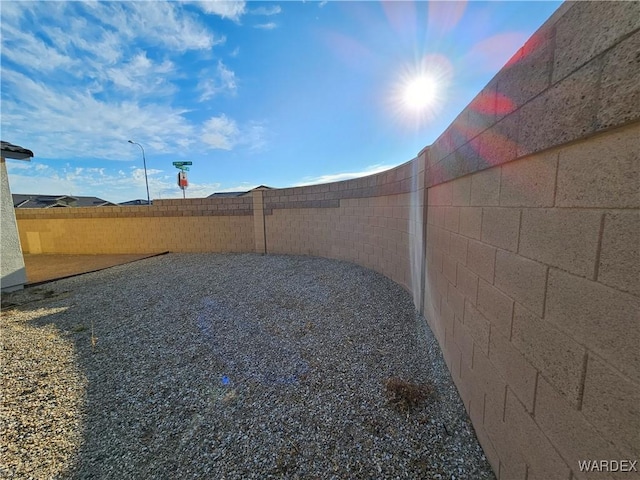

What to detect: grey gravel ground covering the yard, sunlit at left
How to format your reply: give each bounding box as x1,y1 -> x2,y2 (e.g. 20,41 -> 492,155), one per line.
0,254 -> 495,479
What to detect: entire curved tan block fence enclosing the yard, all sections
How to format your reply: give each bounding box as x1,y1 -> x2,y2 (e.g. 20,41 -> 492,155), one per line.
16,2 -> 640,480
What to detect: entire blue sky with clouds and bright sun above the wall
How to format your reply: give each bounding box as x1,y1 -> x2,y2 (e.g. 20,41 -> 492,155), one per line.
0,0 -> 561,202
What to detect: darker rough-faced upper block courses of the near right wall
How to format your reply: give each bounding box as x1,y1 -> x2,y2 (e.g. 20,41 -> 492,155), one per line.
426,1 -> 640,187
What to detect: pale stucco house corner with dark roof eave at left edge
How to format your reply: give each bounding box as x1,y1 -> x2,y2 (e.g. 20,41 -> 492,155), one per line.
0,142 -> 33,292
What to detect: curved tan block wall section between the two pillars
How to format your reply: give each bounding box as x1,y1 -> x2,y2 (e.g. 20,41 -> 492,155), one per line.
264,159 -> 424,294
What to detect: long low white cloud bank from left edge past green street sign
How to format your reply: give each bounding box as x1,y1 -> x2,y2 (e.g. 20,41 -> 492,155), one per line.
2,62 -> 267,160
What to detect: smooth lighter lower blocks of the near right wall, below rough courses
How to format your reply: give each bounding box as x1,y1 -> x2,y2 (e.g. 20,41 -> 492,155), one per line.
425,123 -> 640,479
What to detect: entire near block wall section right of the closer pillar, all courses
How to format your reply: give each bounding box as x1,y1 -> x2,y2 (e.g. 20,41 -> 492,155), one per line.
424,2 -> 640,480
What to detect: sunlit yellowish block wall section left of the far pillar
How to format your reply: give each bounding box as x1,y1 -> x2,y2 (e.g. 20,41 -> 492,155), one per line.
16,197 -> 254,254
